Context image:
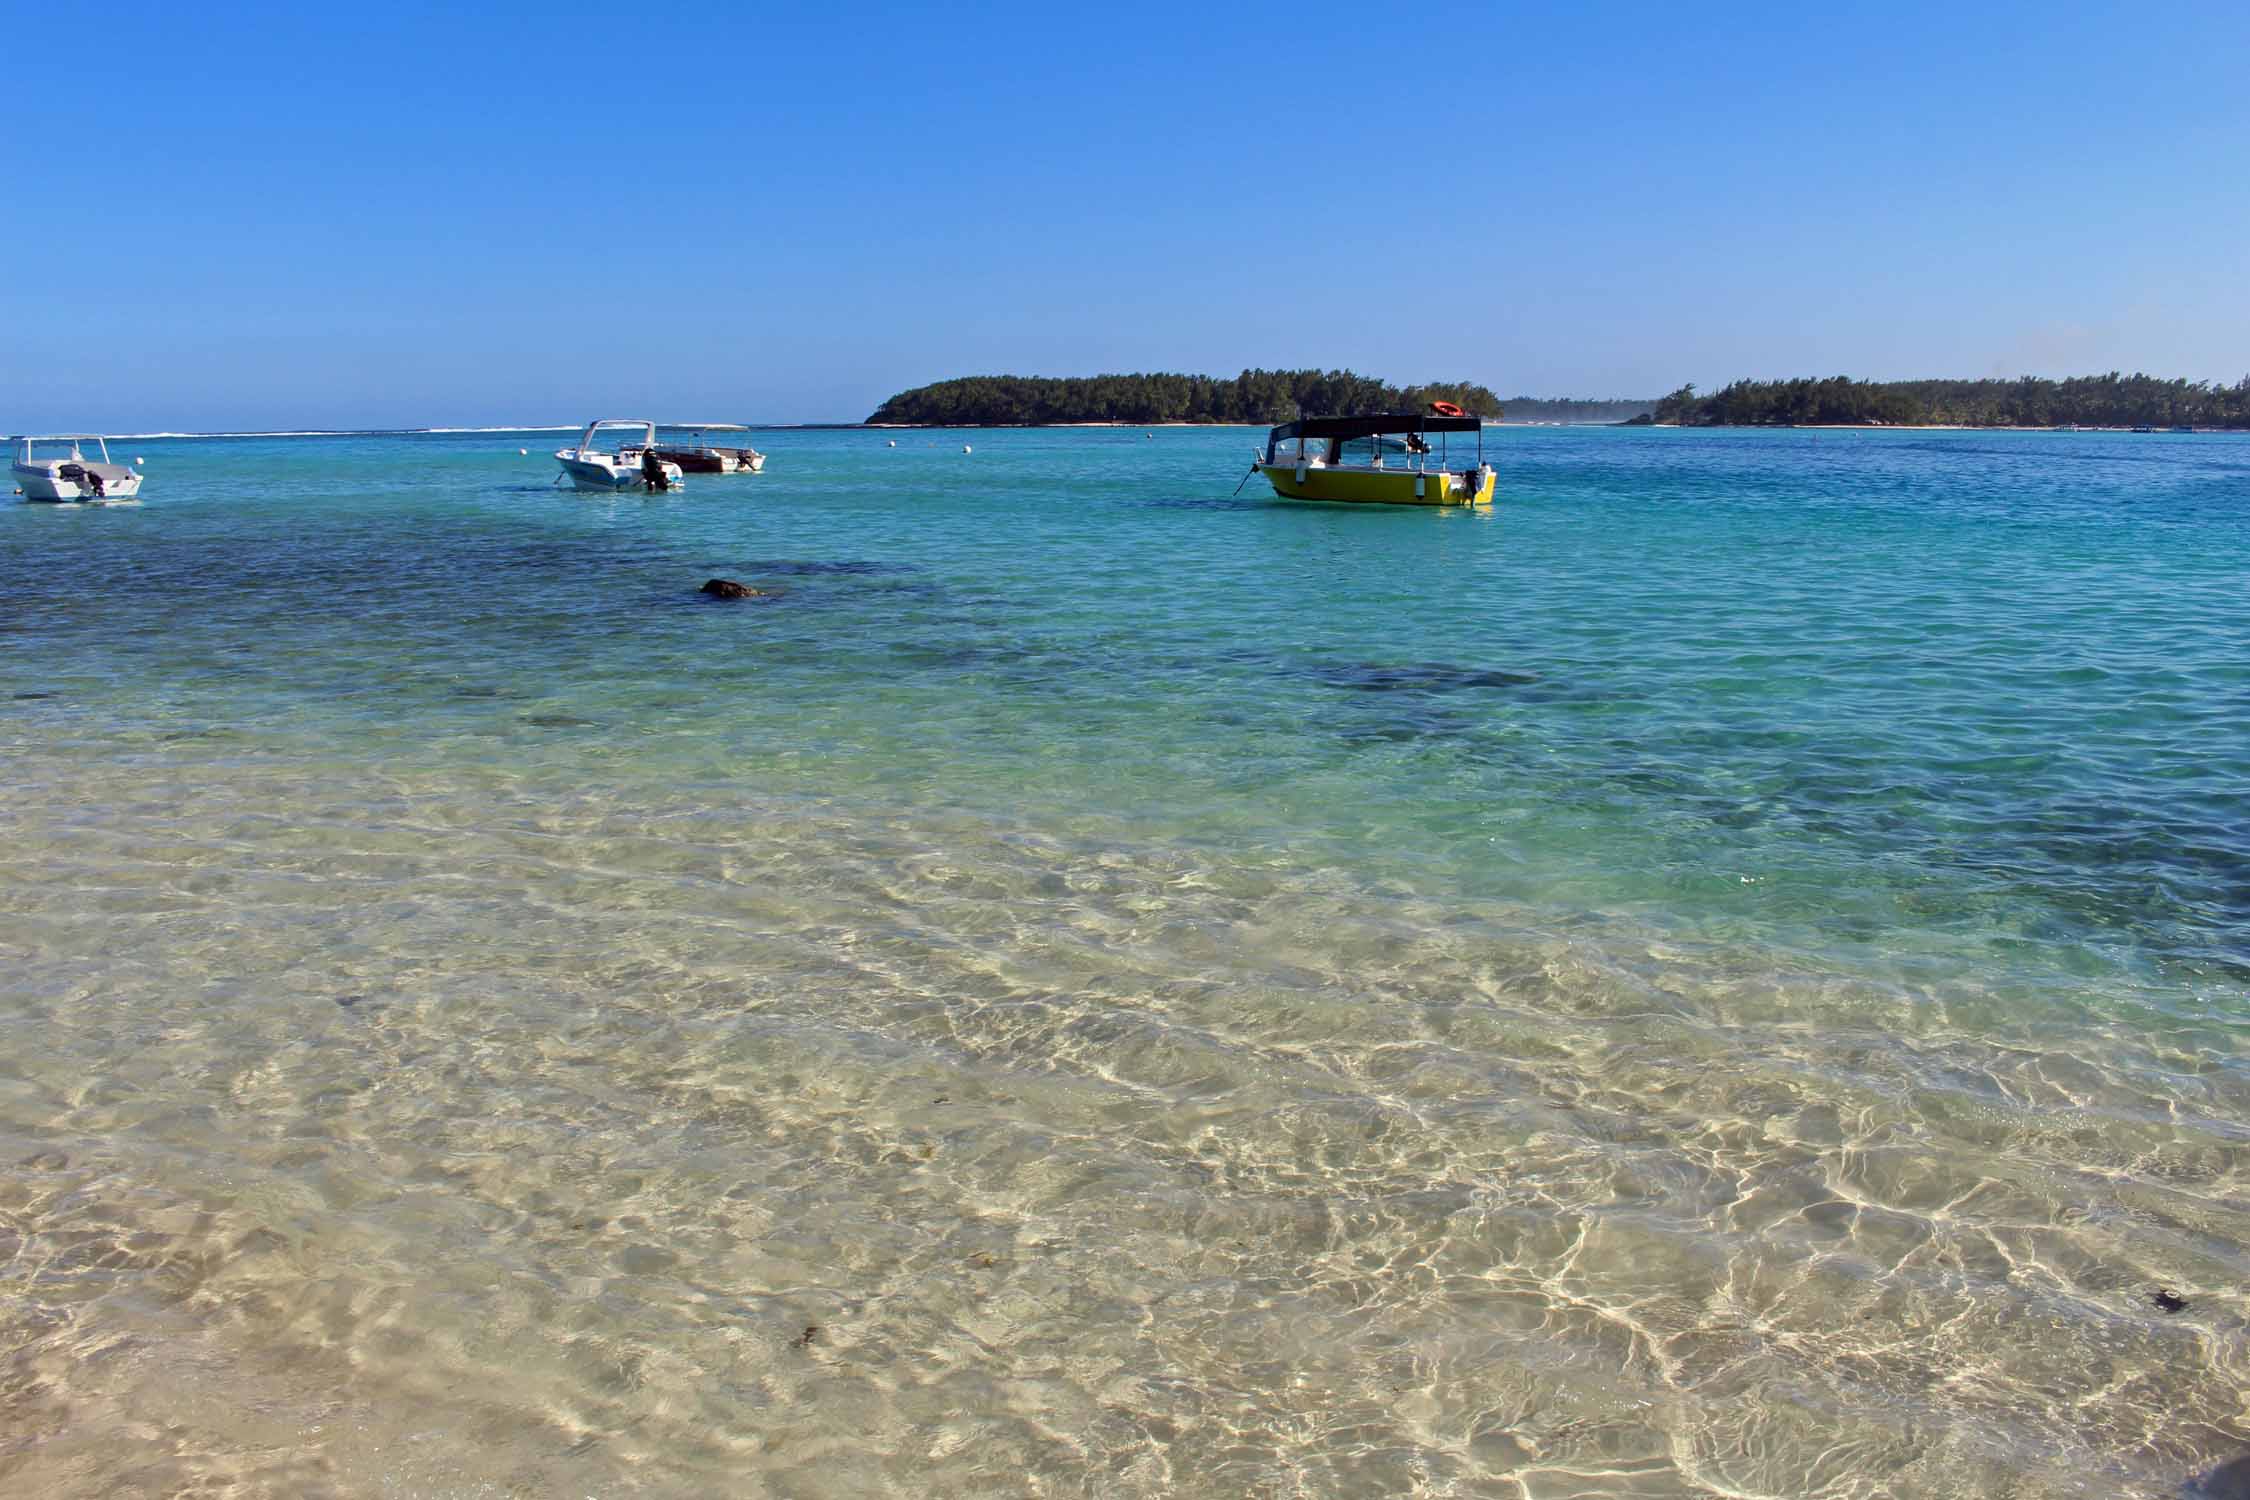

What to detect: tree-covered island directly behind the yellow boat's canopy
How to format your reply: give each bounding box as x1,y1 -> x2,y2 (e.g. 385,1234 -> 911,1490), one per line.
866,369 -> 1501,427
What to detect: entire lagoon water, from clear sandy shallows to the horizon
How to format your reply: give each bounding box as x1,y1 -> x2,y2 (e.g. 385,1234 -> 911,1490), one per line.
0,430 -> 2250,1498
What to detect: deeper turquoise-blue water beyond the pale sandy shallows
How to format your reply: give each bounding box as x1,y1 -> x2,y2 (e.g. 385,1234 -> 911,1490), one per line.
21,430 -> 2250,998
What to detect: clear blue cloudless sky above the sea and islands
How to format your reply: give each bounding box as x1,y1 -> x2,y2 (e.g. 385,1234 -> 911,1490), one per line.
0,0 -> 2250,432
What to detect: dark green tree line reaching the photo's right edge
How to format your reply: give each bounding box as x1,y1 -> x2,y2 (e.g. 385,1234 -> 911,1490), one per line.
1645,371 -> 2250,427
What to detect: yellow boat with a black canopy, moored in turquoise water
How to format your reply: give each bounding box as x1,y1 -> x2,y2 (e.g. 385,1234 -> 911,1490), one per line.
1256,412 -> 1499,506
